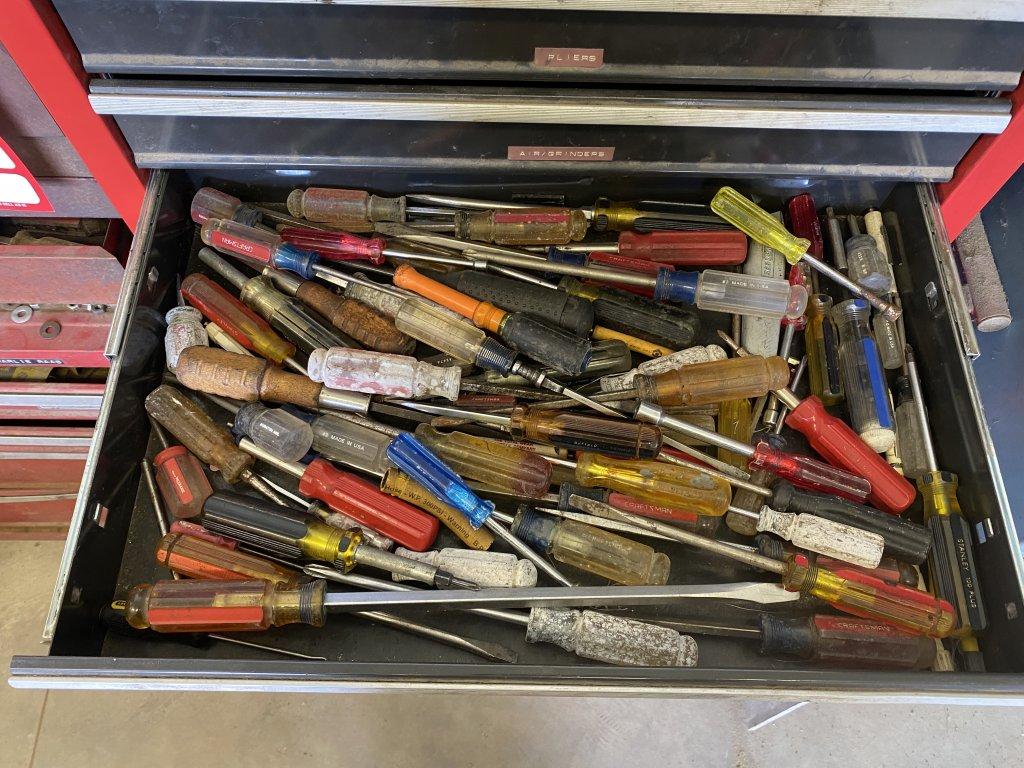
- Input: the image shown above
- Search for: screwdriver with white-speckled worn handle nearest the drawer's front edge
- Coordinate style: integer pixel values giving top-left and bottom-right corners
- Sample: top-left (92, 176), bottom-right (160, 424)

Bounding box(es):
top-left (305, 565), bottom-right (697, 667)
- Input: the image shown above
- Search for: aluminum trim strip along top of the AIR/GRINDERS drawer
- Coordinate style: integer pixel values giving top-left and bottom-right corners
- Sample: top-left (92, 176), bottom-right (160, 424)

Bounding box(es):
top-left (89, 92), bottom-right (1010, 133)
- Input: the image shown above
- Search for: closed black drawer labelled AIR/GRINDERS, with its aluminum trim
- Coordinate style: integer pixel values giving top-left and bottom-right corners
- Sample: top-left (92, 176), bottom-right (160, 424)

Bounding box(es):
top-left (91, 80), bottom-right (1010, 183)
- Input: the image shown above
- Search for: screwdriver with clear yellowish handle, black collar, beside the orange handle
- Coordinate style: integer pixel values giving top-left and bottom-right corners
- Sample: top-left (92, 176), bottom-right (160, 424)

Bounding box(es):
top-left (394, 299), bottom-right (620, 417)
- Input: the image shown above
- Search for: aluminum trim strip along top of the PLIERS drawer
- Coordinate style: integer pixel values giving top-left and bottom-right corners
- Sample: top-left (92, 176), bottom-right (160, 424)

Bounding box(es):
top-left (128, 0), bottom-right (1024, 22)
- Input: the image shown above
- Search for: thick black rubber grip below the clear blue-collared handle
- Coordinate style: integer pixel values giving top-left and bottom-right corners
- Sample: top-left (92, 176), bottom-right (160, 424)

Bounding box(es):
top-left (594, 288), bottom-right (700, 350)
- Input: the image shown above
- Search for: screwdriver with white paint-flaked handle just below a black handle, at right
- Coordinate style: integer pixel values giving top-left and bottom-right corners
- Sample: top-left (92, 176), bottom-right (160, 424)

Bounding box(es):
top-left (570, 497), bottom-right (885, 568)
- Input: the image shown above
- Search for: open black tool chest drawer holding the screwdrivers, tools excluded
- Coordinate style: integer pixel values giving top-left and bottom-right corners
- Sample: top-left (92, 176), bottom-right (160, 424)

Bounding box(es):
top-left (11, 165), bottom-right (1024, 701)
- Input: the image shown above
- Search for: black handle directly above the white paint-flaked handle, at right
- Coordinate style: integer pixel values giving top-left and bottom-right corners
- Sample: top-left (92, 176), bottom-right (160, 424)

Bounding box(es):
top-left (771, 480), bottom-right (932, 565)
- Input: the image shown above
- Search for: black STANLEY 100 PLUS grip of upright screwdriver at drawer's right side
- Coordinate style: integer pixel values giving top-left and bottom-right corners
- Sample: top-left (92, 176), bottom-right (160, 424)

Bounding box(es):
top-left (927, 514), bottom-right (988, 633)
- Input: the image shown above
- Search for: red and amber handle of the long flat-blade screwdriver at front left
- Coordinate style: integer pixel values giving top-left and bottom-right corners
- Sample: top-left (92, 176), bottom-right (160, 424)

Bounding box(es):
top-left (125, 579), bottom-right (326, 632)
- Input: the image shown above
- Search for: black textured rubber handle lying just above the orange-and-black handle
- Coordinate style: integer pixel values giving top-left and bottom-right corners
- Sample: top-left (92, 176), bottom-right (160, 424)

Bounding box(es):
top-left (437, 269), bottom-right (594, 336)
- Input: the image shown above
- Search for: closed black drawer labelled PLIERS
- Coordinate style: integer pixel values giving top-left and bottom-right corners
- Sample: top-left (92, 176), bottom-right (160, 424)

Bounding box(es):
top-left (54, 0), bottom-right (1024, 90)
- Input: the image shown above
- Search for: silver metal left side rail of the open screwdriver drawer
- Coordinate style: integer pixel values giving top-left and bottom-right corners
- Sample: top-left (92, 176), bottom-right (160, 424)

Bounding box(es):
top-left (43, 172), bottom-right (167, 642)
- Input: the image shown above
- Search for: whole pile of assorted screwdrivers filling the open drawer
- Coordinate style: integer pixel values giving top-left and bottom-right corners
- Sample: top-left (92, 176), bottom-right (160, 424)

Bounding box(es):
top-left (115, 187), bottom-right (985, 670)
